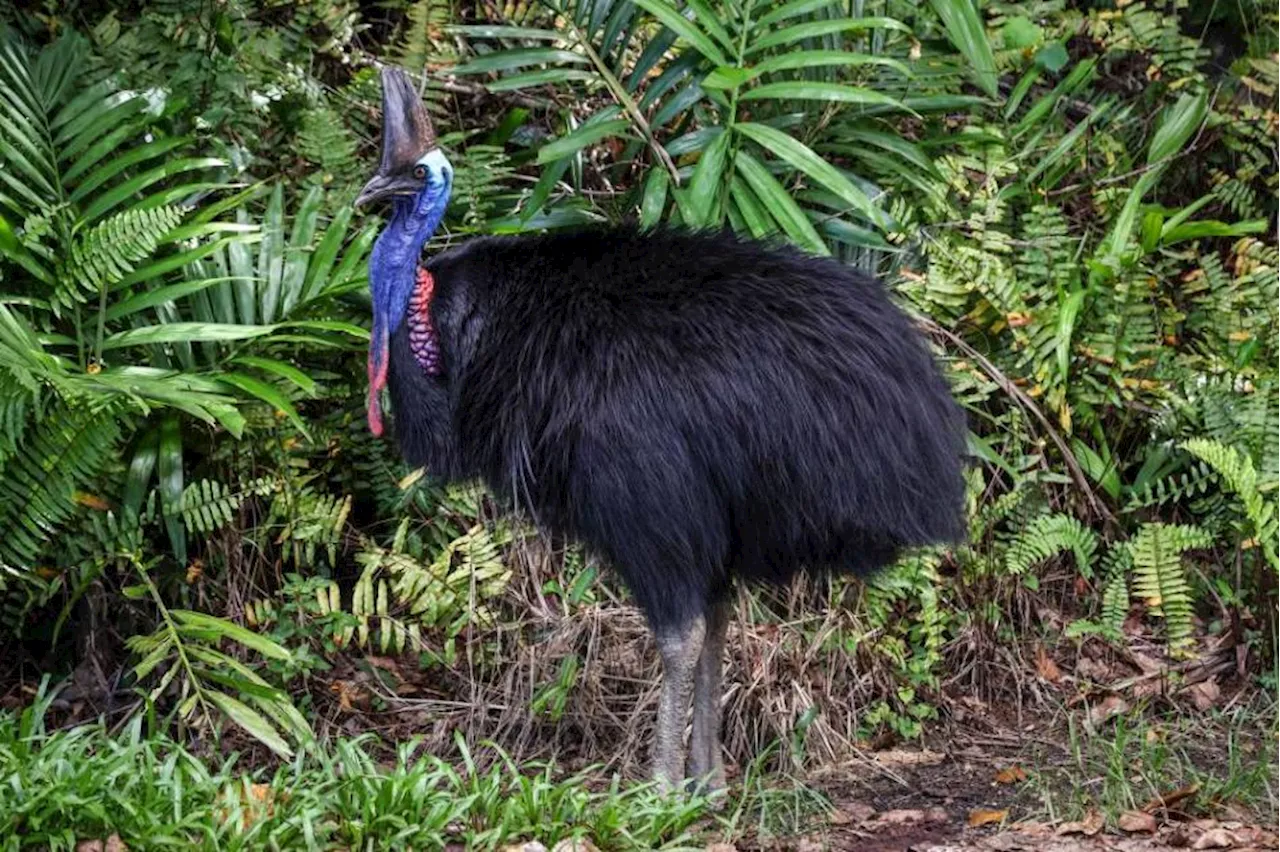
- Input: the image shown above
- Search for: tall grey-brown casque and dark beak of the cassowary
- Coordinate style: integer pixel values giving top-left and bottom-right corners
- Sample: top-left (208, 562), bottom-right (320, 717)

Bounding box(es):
top-left (356, 68), bottom-right (435, 207)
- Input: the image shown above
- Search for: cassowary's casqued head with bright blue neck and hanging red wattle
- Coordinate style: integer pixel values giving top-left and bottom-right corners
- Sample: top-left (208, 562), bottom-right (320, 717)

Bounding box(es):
top-left (356, 68), bottom-right (453, 435)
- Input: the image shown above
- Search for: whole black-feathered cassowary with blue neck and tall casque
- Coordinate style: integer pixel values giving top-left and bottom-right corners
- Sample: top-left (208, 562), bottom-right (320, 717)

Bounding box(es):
top-left (357, 69), bottom-right (965, 788)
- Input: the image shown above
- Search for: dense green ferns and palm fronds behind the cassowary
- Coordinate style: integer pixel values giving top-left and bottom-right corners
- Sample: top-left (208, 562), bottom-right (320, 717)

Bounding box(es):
top-left (0, 0), bottom-right (1280, 777)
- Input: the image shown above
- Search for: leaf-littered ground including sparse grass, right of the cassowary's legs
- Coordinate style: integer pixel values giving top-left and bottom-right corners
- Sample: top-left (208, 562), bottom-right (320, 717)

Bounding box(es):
top-left (709, 709), bottom-right (1280, 852)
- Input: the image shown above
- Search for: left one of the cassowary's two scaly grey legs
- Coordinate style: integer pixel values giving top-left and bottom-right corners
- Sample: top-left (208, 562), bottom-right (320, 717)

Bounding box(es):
top-left (653, 615), bottom-right (707, 792)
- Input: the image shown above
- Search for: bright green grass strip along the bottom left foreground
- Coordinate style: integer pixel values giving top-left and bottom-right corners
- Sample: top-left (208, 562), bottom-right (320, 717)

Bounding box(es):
top-left (0, 680), bottom-right (709, 852)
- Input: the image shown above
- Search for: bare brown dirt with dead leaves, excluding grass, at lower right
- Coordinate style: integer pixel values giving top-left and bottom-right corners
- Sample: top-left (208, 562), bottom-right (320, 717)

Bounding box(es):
top-left (708, 721), bottom-right (1280, 852)
